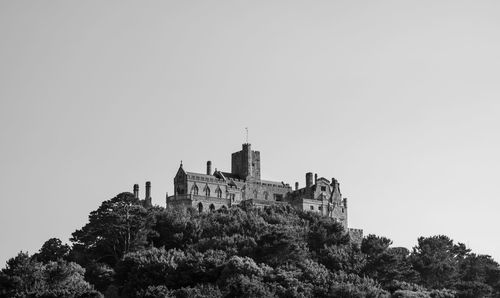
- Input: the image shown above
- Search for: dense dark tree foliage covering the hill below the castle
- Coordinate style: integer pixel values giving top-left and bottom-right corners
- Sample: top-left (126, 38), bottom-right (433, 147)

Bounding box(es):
top-left (0, 193), bottom-right (500, 298)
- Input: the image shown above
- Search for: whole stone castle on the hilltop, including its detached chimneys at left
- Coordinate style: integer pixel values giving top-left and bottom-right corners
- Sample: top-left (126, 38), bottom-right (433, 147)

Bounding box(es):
top-left (164, 143), bottom-right (363, 243)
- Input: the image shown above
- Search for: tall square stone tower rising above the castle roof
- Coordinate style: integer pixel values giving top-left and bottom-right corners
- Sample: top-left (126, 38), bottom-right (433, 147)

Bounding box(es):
top-left (231, 143), bottom-right (260, 180)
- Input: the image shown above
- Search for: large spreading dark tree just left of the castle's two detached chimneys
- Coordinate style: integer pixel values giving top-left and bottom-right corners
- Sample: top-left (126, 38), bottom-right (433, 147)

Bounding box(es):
top-left (71, 192), bottom-right (154, 266)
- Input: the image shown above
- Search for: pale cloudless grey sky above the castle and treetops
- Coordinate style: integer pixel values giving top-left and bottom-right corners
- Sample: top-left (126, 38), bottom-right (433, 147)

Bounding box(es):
top-left (0, 0), bottom-right (500, 267)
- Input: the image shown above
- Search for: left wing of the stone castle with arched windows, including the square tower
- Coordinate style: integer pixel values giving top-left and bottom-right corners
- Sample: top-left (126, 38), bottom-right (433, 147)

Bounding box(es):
top-left (167, 144), bottom-right (292, 212)
